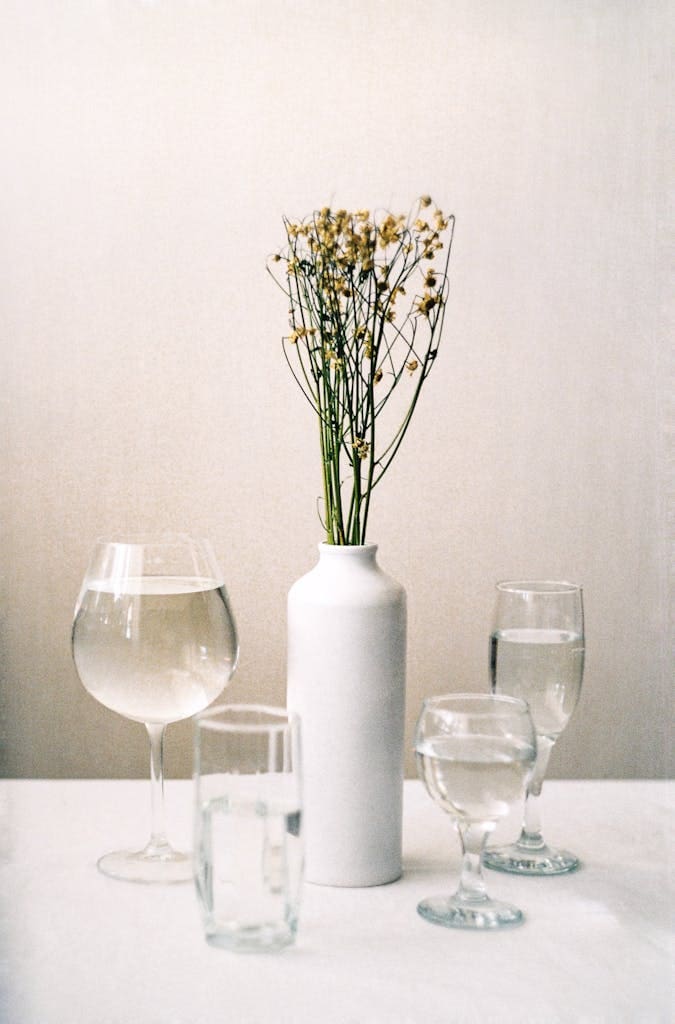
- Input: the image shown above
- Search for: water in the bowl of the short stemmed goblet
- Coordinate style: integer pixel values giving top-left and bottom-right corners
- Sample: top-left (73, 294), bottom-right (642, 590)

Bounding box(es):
top-left (416, 735), bottom-right (535, 822)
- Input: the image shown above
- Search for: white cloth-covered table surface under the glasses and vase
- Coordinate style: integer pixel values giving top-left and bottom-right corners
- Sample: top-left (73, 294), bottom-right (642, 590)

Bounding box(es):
top-left (0, 780), bottom-right (675, 1024)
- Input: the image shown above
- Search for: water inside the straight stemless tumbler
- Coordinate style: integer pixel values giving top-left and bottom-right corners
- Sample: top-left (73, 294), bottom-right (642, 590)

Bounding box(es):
top-left (195, 797), bottom-right (302, 951)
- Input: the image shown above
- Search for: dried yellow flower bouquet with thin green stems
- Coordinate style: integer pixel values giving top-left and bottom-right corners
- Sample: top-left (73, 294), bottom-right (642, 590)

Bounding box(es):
top-left (270, 196), bottom-right (455, 545)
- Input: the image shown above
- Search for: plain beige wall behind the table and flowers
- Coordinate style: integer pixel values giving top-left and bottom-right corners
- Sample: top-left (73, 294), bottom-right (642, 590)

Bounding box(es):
top-left (0, 0), bottom-right (675, 777)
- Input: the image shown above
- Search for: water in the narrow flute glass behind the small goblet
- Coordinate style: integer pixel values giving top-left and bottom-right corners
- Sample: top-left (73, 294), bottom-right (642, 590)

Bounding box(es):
top-left (490, 629), bottom-right (584, 738)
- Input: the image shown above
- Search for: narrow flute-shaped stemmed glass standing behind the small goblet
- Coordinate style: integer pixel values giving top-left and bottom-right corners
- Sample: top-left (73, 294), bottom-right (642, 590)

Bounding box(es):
top-left (484, 580), bottom-right (584, 874)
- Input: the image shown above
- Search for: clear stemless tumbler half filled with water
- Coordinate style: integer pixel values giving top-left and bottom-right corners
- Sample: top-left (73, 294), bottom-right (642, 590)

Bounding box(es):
top-left (194, 705), bottom-right (303, 952)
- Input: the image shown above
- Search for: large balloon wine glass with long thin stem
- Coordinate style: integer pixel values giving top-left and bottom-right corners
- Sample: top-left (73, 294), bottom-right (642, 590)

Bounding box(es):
top-left (72, 534), bottom-right (239, 882)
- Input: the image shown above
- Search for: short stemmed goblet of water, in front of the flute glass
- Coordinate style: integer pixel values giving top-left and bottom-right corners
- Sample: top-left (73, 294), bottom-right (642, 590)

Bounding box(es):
top-left (415, 693), bottom-right (537, 929)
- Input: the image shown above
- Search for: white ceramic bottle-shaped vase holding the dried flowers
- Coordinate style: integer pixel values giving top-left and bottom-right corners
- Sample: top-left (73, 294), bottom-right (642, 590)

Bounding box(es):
top-left (288, 544), bottom-right (406, 886)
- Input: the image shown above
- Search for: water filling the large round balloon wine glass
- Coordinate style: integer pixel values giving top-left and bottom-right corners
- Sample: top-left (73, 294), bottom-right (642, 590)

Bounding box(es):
top-left (73, 577), bottom-right (237, 723)
